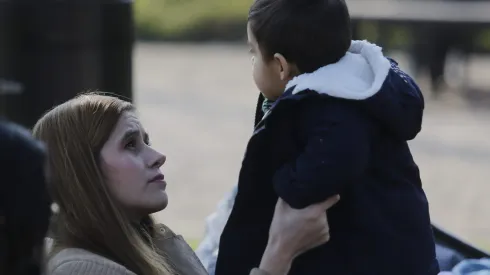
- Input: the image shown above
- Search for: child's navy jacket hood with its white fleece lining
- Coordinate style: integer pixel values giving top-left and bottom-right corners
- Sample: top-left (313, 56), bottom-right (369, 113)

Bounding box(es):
top-left (286, 41), bottom-right (424, 140)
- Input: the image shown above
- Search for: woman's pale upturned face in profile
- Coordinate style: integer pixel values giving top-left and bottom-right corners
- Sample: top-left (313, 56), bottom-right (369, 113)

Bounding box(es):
top-left (100, 112), bottom-right (168, 219)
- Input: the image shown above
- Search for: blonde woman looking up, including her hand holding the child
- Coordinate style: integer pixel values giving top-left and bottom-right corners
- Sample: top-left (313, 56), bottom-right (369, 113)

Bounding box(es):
top-left (33, 94), bottom-right (338, 275)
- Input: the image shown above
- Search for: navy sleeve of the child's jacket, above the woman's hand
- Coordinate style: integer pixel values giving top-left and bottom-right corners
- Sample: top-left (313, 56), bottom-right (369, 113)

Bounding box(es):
top-left (273, 100), bottom-right (370, 208)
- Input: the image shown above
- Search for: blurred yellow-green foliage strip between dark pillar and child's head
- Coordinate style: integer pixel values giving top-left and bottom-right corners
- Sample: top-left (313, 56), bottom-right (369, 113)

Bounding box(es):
top-left (134, 0), bottom-right (252, 39)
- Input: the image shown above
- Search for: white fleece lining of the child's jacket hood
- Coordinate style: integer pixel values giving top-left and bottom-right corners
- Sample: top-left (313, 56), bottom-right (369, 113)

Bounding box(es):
top-left (286, 41), bottom-right (391, 100)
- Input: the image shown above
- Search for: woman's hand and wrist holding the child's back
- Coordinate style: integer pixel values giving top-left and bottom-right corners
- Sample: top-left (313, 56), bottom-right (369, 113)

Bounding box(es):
top-left (260, 195), bottom-right (340, 275)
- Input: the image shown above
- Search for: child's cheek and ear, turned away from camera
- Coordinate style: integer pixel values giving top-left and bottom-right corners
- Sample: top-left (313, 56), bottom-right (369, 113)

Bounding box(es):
top-left (247, 23), bottom-right (293, 100)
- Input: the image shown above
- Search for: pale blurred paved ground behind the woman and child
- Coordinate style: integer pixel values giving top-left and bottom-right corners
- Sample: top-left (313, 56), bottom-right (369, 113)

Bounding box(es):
top-left (135, 44), bottom-right (490, 250)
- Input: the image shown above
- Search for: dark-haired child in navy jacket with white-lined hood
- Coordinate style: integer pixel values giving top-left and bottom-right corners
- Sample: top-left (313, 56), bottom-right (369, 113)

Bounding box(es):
top-left (216, 0), bottom-right (439, 275)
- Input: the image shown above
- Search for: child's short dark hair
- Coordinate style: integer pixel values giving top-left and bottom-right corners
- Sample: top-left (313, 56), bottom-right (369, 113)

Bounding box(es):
top-left (248, 0), bottom-right (352, 73)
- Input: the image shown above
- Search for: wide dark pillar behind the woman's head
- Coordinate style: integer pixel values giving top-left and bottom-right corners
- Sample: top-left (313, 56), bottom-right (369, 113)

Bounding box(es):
top-left (0, 0), bottom-right (133, 127)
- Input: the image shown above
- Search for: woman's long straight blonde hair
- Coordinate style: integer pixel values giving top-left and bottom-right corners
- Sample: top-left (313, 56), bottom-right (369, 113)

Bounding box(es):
top-left (33, 93), bottom-right (172, 275)
